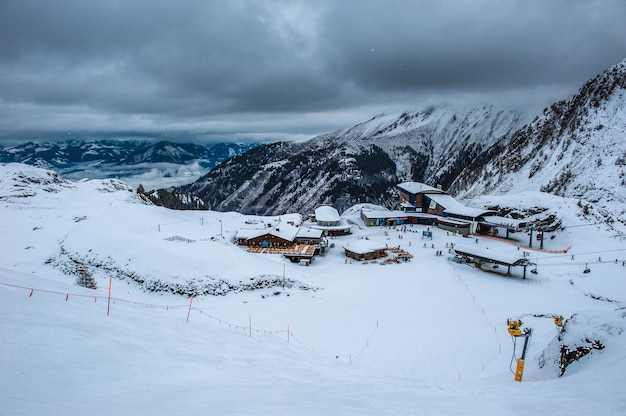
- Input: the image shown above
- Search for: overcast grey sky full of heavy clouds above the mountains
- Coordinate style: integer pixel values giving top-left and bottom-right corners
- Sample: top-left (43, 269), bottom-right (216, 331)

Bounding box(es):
top-left (0, 0), bottom-right (626, 142)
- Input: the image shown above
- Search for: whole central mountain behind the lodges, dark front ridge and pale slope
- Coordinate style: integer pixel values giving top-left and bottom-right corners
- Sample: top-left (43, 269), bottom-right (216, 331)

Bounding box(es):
top-left (174, 107), bottom-right (525, 214)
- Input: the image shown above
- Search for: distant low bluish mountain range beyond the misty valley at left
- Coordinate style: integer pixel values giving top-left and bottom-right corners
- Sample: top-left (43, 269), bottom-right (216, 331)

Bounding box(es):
top-left (0, 140), bottom-right (258, 189)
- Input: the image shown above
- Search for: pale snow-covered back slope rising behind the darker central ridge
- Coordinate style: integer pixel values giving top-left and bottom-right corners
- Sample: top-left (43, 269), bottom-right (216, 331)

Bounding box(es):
top-left (330, 106), bottom-right (525, 188)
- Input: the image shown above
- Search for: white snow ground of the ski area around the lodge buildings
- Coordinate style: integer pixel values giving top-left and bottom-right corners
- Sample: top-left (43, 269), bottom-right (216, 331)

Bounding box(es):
top-left (0, 164), bottom-right (626, 415)
